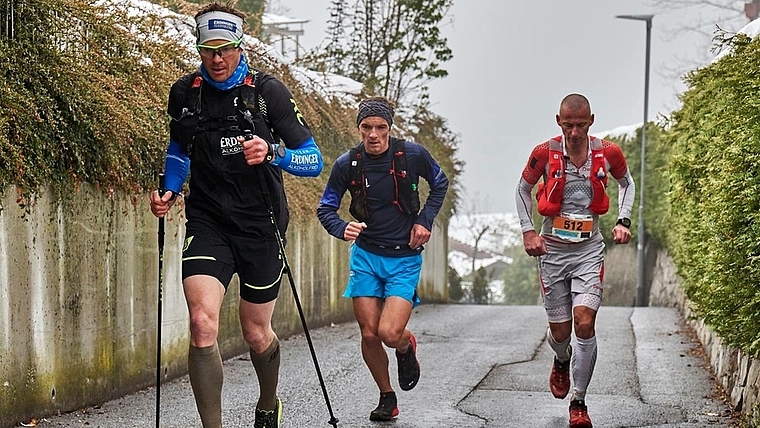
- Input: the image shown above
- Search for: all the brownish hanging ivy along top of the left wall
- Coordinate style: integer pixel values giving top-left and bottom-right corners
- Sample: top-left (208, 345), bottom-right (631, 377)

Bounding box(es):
top-left (0, 0), bottom-right (461, 219)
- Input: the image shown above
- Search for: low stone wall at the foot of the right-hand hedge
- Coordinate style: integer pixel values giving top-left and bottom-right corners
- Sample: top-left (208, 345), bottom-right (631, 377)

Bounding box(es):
top-left (649, 252), bottom-right (760, 426)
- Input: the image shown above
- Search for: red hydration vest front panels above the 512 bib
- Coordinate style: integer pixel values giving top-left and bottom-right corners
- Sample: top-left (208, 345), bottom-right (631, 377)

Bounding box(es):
top-left (536, 136), bottom-right (610, 217)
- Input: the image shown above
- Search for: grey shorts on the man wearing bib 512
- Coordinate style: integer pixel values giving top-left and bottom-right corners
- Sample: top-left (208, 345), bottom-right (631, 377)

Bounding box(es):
top-left (538, 233), bottom-right (604, 322)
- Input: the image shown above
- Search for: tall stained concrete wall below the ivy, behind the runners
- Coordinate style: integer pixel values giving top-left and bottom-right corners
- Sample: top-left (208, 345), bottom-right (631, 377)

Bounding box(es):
top-left (0, 186), bottom-right (448, 426)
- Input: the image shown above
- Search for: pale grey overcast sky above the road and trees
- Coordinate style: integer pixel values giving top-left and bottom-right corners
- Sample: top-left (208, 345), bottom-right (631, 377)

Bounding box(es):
top-left (272, 0), bottom-right (744, 213)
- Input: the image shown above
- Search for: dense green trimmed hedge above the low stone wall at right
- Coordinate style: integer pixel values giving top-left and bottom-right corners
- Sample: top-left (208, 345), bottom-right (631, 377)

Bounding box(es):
top-left (667, 35), bottom-right (760, 356)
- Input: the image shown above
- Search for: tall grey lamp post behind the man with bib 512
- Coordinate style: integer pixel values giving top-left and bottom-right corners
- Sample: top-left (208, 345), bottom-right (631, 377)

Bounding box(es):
top-left (615, 15), bottom-right (654, 306)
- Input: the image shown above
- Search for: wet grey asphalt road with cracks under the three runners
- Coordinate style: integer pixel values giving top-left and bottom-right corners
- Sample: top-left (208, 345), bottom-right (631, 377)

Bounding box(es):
top-left (31, 305), bottom-right (735, 428)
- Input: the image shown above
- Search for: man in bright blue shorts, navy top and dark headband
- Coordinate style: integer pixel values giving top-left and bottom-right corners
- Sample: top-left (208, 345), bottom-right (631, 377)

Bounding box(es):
top-left (317, 97), bottom-right (449, 421)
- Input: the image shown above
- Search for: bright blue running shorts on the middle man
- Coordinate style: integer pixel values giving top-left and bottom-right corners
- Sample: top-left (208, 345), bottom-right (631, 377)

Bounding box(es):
top-left (343, 245), bottom-right (422, 307)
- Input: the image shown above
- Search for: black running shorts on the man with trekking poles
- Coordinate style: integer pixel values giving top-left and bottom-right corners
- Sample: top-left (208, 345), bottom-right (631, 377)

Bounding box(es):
top-left (182, 221), bottom-right (285, 303)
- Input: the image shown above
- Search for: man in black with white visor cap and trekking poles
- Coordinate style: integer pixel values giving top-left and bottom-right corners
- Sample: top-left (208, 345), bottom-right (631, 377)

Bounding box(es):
top-left (150, 3), bottom-right (335, 428)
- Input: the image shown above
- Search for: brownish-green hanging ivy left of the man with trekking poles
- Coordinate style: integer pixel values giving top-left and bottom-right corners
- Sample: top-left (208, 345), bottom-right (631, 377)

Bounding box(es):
top-left (0, 0), bottom-right (190, 202)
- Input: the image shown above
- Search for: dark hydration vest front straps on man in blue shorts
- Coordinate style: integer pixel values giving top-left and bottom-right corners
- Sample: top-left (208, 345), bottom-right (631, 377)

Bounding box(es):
top-left (348, 137), bottom-right (420, 221)
